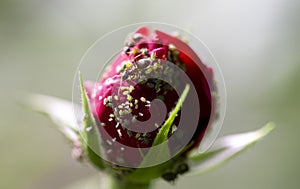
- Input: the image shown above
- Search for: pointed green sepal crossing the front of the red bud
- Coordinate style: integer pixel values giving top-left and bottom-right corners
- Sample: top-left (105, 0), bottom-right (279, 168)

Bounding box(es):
top-left (141, 84), bottom-right (190, 167)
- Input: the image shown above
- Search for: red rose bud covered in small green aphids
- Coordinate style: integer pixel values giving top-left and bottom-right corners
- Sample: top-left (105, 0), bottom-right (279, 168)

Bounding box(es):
top-left (85, 27), bottom-right (214, 169)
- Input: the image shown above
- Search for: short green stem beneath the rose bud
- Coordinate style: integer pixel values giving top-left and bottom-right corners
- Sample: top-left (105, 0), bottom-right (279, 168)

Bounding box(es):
top-left (110, 176), bottom-right (151, 189)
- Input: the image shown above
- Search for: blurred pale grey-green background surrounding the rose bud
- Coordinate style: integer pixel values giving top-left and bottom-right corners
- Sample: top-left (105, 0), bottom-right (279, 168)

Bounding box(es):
top-left (0, 0), bottom-right (300, 189)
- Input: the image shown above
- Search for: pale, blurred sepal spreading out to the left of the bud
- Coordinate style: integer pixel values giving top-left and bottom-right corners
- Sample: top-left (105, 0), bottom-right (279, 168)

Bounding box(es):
top-left (25, 94), bottom-right (80, 142)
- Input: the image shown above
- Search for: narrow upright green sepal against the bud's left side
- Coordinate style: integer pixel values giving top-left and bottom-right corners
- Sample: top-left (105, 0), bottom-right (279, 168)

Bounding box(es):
top-left (79, 73), bottom-right (104, 169)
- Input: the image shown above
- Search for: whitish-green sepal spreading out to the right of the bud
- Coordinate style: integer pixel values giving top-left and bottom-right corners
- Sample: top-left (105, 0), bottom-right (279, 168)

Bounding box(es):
top-left (188, 123), bottom-right (275, 175)
